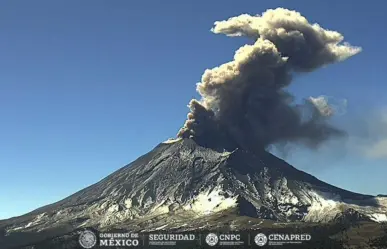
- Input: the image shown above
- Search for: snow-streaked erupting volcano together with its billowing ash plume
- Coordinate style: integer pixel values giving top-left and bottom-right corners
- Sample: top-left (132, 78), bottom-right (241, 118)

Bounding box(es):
top-left (0, 8), bottom-right (387, 248)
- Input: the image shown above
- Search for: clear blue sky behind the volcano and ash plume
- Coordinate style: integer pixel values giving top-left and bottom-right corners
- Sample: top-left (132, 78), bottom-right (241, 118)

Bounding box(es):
top-left (0, 0), bottom-right (387, 219)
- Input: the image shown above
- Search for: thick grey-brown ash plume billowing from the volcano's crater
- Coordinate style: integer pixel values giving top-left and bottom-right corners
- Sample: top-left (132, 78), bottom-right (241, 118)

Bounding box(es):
top-left (178, 8), bottom-right (361, 150)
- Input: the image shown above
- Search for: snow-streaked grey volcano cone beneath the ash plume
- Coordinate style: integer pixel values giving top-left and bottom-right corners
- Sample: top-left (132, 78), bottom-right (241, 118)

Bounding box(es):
top-left (0, 139), bottom-right (387, 248)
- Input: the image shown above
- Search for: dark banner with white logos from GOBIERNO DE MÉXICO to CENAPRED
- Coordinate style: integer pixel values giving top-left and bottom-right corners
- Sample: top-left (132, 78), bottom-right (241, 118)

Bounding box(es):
top-left (79, 230), bottom-right (324, 249)
